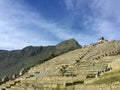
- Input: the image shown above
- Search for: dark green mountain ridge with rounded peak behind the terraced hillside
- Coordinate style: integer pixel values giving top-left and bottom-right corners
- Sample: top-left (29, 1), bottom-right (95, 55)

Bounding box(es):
top-left (0, 39), bottom-right (81, 78)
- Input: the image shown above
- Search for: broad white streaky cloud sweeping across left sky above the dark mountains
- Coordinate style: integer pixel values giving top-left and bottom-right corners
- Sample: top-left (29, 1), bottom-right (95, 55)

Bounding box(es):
top-left (0, 0), bottom-right (95, 49)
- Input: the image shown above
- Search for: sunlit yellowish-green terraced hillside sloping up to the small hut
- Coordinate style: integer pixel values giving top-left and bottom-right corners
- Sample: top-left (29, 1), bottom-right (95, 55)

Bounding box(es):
top-left (0, 41), bottom-right (120, 90)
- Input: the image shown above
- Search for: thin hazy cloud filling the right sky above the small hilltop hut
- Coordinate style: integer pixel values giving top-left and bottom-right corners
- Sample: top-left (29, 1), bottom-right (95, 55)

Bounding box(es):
top-left (65, 0), bottom-right (120, 39)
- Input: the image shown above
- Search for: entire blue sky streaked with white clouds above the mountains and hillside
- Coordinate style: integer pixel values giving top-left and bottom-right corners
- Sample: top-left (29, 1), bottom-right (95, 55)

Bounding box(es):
top-left (0, 0), bottom-right (120, 50)
